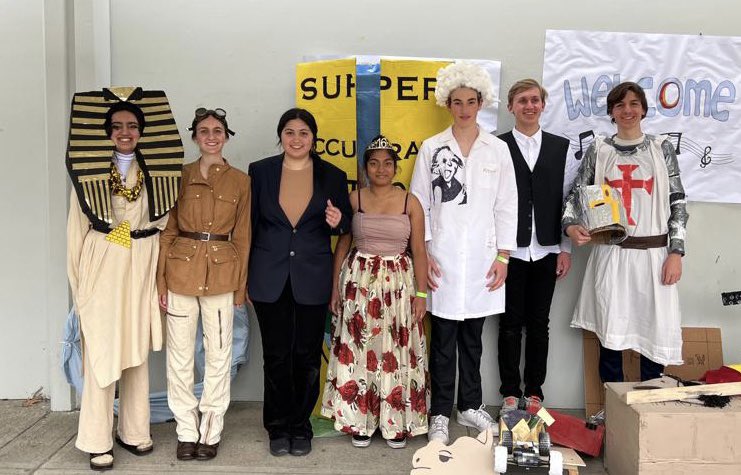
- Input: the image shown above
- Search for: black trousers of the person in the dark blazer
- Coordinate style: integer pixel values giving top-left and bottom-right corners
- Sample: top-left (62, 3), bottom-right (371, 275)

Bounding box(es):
top-left (253, 277), bottom-right (327, 439)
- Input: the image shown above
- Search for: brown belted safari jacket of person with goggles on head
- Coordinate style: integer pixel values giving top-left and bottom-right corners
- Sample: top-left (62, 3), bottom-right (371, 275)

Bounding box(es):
top-left (157, 159), bottom-right (252, 305)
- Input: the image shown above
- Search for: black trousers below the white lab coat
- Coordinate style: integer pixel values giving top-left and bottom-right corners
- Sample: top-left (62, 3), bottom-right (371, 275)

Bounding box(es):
top-left (430, 315), bottom-right (485, 417)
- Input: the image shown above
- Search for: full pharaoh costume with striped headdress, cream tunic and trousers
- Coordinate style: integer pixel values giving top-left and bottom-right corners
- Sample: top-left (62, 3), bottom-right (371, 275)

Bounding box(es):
top-left (66, 88), bottom-right (183, 458)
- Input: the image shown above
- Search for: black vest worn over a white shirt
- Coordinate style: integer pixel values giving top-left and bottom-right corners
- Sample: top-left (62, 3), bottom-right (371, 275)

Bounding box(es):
top-left (499, 132), bottom-right (569, 247)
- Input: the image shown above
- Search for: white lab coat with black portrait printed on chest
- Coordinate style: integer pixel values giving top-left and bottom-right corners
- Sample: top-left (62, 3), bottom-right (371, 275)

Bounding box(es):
top-left (411, 127), bottom-right (517, 320)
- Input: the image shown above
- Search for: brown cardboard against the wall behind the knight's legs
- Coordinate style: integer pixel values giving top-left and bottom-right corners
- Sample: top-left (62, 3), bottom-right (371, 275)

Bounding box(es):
top-left (583, 327), bottom-right (723, 417)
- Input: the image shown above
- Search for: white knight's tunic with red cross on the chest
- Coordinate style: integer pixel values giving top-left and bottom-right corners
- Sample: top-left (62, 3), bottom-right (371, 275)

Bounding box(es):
top-left (571, 137), bottom-right (682, 365)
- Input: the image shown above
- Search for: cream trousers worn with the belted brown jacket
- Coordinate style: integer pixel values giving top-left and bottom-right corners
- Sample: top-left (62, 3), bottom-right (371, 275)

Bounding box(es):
top-left (167, 291), bottom-right (234, 445)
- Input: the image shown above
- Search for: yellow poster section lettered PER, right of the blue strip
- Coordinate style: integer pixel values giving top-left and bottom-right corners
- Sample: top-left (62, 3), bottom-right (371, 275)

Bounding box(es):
top-left (381, 59), bottom-right (451, 188)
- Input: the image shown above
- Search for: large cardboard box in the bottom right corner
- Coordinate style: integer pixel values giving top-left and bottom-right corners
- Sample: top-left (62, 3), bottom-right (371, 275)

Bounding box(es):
top-left (605, 383), bottom-right (741, 475)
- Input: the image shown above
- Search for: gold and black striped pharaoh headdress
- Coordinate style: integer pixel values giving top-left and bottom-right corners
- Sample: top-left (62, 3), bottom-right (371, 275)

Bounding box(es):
top-left (66, 87), bottom-right (184, 231)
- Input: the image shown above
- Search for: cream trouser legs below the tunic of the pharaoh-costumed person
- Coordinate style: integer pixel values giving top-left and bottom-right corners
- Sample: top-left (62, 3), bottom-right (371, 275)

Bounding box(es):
top-left (75, 338), bottom-right (152, 454)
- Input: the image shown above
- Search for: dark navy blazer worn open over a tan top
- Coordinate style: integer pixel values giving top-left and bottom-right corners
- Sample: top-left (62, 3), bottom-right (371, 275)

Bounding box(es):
top-left (248, 154), bottom-right (352, 305)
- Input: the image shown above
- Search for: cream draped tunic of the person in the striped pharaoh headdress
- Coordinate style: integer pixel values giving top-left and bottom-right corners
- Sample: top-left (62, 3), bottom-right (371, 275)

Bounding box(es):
top-left (67, 162), bottom-right (169, 388)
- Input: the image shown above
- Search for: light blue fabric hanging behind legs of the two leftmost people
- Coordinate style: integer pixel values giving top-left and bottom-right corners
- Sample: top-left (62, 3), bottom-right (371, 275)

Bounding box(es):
top-left (62, 305), bottom-right (249, 423)
